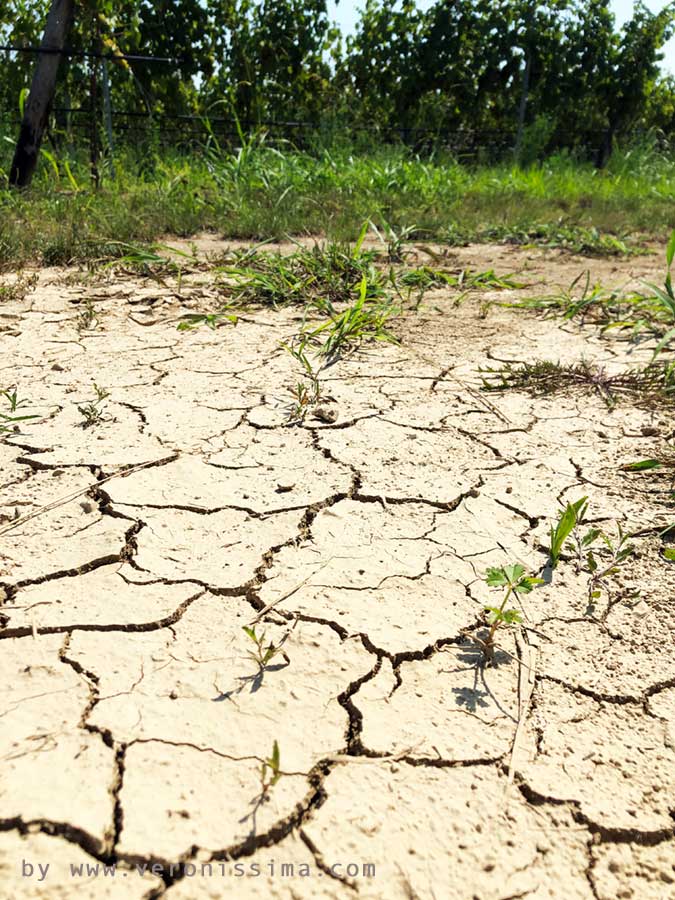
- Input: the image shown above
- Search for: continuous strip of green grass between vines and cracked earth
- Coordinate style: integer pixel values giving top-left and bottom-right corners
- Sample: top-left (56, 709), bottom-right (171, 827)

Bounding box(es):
top-left (0, 140), bottom-right (675, 269)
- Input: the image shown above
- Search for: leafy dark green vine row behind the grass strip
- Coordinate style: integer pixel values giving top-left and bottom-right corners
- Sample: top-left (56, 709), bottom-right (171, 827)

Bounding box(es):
top-left (0, 0), bottom-right (675, 164)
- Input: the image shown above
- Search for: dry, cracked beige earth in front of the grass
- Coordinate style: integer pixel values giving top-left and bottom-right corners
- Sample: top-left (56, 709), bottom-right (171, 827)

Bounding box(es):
top-left (0, 242), bottom-right (675, 900)
